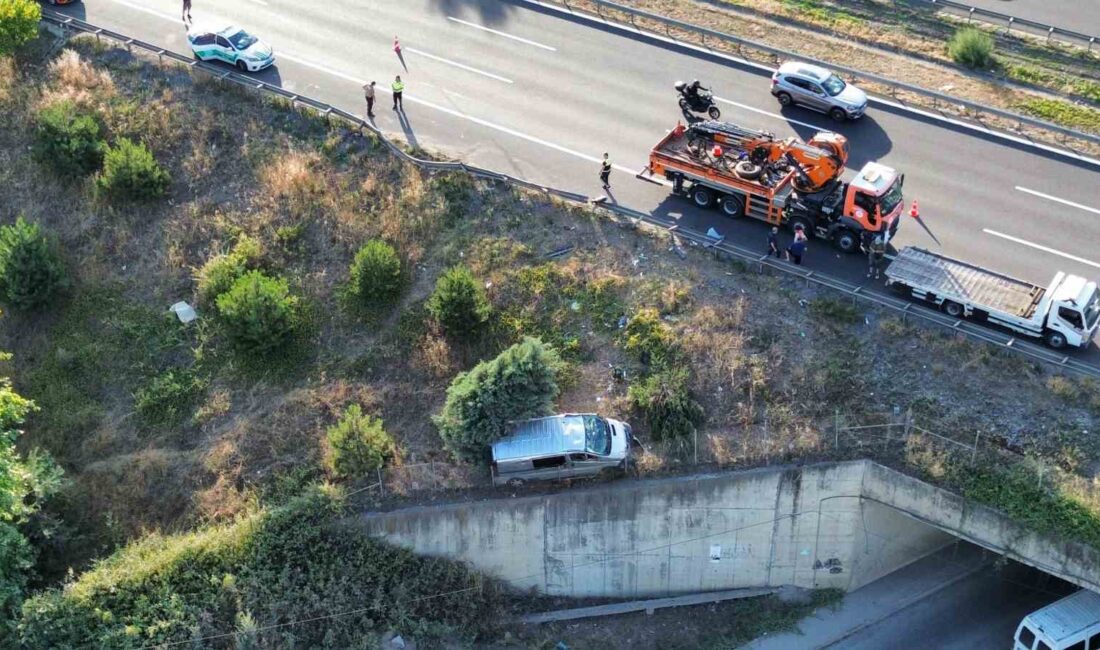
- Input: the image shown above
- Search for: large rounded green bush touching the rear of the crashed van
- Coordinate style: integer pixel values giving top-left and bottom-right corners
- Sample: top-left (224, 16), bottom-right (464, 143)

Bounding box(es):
top-left (435, 338), bottom-right (561, 461)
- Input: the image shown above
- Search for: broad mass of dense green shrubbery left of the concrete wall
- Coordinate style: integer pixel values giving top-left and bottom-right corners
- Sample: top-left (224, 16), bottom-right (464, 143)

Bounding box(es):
top-left (13, 488), bottom-right (505, 650)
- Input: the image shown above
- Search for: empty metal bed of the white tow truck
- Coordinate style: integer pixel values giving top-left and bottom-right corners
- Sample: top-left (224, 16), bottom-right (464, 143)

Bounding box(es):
top-left (886, 246), bottom-right (1045, 319)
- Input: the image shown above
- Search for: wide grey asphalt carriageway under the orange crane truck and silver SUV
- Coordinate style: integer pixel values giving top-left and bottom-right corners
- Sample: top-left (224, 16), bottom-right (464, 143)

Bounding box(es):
top-left (49, 0), bottom-right (1100, 360)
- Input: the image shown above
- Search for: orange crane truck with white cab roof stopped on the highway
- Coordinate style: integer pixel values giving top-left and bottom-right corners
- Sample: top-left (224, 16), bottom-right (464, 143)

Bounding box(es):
top-left (639, 120), bottom-right (905, 253)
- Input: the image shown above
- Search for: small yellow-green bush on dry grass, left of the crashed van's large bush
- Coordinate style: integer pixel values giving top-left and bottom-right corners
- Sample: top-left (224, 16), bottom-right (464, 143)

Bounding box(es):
top-left (325, 404), bottom-right (395, 477)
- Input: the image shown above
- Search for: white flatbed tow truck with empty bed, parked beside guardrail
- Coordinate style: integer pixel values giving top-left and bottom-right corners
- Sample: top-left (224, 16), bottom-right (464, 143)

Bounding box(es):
top-left (886, 246), bottom-right (1100, 348)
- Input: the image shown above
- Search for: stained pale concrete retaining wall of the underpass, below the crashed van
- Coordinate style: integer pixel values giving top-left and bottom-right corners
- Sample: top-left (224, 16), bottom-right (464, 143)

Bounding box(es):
top-left (363, 461), bottom-right (1100, 597)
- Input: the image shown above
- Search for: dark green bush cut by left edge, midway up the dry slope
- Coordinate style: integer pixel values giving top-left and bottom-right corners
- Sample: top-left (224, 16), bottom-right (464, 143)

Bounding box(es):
top-left (0, 217), bottom-right (65, 309)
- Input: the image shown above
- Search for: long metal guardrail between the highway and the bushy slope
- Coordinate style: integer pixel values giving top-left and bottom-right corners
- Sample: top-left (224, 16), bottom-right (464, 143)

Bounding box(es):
top-left (43, 10), bottom-right (1100, 378)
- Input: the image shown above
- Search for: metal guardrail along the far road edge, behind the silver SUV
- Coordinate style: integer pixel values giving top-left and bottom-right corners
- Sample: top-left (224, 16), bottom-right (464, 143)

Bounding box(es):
top-left (539, 0), bottom-right (1100, 145)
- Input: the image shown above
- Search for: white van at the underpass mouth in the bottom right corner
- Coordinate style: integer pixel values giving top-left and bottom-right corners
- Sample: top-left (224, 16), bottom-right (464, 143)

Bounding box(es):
top-left (1013, 590), bottom-right (1100, 650)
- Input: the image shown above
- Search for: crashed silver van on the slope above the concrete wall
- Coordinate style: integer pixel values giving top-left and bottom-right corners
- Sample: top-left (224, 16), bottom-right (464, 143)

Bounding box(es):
top-left (492, 414), bottom-right (637, 487)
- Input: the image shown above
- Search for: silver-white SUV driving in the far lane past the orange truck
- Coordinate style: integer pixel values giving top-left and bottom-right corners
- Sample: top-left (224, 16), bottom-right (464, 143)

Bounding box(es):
top-left (771, 62), bottom-right (867, 122)
